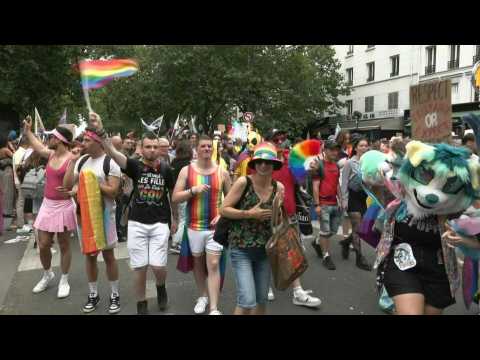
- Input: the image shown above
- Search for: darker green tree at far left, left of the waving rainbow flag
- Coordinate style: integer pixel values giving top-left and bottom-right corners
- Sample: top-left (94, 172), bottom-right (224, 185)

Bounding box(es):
top-left (0, 45), bottom-right (81, 126)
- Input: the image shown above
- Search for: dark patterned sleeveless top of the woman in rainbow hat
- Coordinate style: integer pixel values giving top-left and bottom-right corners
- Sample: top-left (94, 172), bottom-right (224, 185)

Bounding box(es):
top-left (228, 179), bottom-right (277, 249)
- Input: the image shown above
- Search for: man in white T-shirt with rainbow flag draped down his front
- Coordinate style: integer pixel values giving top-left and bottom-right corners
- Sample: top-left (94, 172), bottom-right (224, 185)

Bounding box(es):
top-left (63, 113), bottom-right (121, 314)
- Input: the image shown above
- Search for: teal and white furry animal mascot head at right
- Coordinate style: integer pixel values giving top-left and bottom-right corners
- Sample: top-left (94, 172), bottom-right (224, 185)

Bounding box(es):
top-left (360, 141), bottom-right (480, 218)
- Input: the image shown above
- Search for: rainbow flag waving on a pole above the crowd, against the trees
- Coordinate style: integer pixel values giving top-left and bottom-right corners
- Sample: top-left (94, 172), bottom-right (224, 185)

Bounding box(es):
top-left (79, 59), bottom-right (138, 90)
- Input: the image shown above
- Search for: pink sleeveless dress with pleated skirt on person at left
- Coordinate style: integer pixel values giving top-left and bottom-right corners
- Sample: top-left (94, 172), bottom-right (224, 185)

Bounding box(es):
top-left (33, 156), bottom-right (77, 233)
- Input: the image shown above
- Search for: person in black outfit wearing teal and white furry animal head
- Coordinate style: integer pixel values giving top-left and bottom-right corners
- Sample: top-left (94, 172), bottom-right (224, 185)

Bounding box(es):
top-left (360, 136), bottom-right (480, 315)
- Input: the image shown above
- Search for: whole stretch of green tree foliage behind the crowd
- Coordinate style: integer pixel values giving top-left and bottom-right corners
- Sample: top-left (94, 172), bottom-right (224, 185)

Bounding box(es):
top-left (0, 45), bottom-right (349, 136)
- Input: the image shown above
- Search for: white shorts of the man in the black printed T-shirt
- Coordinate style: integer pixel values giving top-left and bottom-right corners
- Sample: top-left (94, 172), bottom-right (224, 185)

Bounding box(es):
top-left (127, 221), bottom-right (170, 269)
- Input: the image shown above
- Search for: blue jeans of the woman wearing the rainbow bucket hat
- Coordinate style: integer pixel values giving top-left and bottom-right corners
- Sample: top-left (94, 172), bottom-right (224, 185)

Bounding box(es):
top-left (230, 247), bottom-right (271, 309)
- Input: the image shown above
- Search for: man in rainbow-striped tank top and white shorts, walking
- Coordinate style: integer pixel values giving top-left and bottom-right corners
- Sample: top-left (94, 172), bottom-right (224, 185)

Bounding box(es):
top-left (172, 135), bottom-right (231, 315)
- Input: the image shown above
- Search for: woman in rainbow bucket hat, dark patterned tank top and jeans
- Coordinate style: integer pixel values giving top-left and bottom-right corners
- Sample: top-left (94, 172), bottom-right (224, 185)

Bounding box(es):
top-left (220, 143), bottom-right (285, 315)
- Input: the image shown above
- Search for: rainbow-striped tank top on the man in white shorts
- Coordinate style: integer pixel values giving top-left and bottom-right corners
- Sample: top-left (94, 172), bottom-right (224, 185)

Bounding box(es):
top-left (187, 165), bottom-right (222, 231)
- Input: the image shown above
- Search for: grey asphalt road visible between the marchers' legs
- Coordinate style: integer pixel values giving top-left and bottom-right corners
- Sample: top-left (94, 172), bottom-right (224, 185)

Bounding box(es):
top-left (0, 228), bottom-right (478, 316)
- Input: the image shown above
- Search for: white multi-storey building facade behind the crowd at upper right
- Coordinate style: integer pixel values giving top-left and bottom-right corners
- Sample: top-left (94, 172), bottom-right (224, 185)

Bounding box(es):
top-left (329, 45), bottom-right (480, 138)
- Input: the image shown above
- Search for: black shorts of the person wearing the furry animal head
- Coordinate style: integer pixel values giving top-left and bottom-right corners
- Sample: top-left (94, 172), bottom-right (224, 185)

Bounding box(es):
top-left (384, 245), bottom-right (455, 309)
